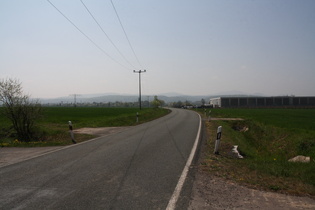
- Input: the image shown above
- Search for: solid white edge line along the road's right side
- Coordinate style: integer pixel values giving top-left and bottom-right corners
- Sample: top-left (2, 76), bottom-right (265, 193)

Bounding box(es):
top-left (166, 113), bottom-right (201, 210)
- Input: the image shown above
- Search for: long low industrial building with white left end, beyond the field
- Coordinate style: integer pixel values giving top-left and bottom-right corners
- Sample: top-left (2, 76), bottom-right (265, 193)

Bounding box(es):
top-left (210, 96), bottom-right (315, 108)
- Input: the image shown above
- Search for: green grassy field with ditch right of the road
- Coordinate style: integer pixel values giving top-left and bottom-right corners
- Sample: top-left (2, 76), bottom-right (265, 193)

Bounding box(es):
top-left (202, 109), bottom-right (315, 196)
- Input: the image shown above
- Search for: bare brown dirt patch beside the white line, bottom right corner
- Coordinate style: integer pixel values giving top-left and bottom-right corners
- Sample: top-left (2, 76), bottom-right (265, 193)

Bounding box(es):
top-left (188, 169), bottom-right (315, 210)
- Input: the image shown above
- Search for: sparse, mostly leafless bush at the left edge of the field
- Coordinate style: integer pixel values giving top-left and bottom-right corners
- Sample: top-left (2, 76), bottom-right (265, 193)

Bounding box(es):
top-left (0, 79), bottom-right (42, 142)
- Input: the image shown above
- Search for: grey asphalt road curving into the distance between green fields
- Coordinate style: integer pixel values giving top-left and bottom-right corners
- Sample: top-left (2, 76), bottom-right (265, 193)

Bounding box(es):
top-left (0, 109), bottom-right (199, 209)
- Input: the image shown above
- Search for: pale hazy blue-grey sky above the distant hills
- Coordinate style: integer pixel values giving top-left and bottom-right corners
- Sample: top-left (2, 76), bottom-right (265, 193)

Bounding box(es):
top-left (0, 0), bottom-right (315, 98)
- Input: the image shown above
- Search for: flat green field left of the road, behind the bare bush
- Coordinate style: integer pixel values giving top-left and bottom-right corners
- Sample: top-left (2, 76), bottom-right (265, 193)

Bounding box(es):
top-left (0, 107), bottom-right (169, 146)
